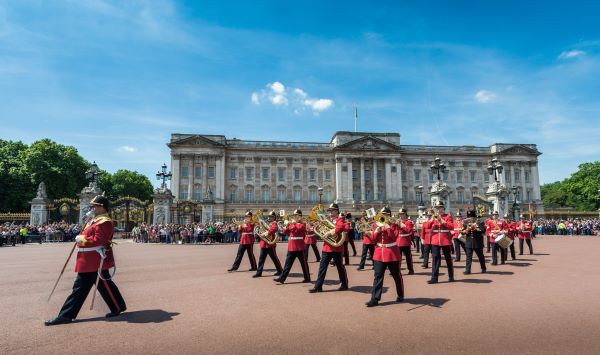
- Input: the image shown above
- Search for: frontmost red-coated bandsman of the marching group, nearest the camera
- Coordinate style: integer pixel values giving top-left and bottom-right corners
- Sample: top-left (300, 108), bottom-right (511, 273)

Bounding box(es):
top-left (365, 207), bottom-right (404, 307)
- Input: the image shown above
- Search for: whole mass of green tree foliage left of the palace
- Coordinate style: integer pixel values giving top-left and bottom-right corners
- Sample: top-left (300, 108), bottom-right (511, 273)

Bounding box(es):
top-left (0, 139), bottom-right (152, 212)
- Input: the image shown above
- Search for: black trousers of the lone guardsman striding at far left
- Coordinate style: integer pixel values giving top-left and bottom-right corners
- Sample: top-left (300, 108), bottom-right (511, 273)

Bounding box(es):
top-left (58, 270), bottom-right (126, 319)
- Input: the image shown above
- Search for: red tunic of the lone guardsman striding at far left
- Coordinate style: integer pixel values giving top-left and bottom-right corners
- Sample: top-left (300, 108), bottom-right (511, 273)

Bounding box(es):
top-left (75, 214), bottom-right (115, 272)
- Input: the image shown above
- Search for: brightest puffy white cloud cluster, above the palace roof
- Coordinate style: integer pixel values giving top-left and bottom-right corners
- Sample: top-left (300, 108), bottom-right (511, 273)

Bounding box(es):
top-left (250, 81), bottom-right (334, 115)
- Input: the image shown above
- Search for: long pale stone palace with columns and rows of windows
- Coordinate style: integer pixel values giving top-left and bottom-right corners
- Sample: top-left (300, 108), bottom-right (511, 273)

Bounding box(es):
top-left (167, 131), bottom-right (543, 222)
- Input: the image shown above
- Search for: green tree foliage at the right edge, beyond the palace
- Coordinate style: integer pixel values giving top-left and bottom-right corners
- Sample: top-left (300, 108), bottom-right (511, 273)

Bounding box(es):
top-left (541, 161), bottom-right (600, 211)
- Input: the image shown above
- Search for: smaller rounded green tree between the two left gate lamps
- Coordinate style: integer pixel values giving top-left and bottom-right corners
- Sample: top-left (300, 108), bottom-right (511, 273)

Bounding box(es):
top-left (106, 169), bottom-right (152, 201)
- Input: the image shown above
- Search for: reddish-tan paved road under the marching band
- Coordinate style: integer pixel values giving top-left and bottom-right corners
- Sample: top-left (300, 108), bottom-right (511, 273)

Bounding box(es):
top-left (0, 236), bottom-right (600, 354)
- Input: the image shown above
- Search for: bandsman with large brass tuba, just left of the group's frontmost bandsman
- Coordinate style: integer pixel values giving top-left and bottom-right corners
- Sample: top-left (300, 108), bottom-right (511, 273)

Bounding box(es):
top-left (308, 203), bottom-right (348, 293)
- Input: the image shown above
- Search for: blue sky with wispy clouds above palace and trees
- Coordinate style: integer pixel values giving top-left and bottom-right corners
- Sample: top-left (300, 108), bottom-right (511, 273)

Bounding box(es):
top-left (0, 0), bottom-right (600, 185)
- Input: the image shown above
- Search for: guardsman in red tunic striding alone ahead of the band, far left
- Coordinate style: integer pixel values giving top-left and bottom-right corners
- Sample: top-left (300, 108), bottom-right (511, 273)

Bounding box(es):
top-left (44, 196), bottom-right (127, 325)
